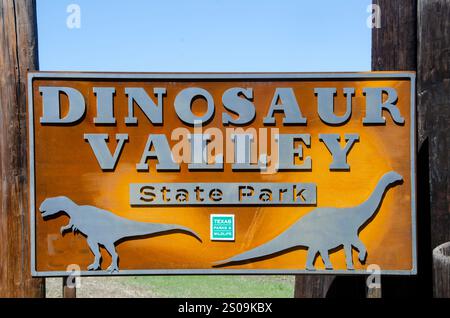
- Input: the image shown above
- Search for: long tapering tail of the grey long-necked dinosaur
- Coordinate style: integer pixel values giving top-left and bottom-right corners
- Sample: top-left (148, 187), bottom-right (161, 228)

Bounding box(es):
top-left (213, 222), bottom-right (302, 266)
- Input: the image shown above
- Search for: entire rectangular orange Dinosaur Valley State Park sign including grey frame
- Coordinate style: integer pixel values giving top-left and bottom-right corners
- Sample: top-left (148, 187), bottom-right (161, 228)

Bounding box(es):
top-left (28, 72), bottom-right (416, 276)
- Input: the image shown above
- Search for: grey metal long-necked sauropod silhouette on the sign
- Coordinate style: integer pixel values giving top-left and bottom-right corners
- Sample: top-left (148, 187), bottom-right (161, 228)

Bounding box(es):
top-left (214, 171), bottom-right (403, 270)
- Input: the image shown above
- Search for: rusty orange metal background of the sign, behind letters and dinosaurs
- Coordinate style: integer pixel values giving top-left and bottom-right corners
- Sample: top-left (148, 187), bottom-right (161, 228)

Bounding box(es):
top-left (27, 73), bottom-right (414, 275)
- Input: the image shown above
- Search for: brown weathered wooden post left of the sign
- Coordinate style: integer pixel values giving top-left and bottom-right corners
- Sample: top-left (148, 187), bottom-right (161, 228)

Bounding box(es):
top-left (0, 0), bottom-right (45, 297)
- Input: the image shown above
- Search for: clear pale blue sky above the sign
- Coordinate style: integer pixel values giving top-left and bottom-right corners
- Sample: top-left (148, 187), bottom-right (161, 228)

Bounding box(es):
top-left (37, 0), bottom-right (371, 72)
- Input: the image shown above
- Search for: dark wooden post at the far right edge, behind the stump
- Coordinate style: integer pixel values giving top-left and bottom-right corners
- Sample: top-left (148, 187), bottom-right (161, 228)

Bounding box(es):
top-left (417, 0), bottom-right (450, 297)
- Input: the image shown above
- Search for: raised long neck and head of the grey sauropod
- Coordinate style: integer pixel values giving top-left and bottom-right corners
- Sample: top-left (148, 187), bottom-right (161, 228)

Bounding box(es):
top-left (352, 176), bottom-right (392, 228)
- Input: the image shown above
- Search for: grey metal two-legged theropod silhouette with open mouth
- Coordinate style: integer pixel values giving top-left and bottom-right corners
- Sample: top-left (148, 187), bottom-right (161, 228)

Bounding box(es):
top-left (39, 196), bottom-right (201, 273)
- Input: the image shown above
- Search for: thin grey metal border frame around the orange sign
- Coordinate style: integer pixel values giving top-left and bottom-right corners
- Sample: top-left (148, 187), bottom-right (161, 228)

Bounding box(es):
top-left (27, 71), bottom-right (417, 277)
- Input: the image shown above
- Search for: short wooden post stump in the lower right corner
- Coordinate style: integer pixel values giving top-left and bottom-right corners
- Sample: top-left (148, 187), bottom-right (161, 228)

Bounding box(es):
top-left (433, 242), bottom-right (450, 298)
